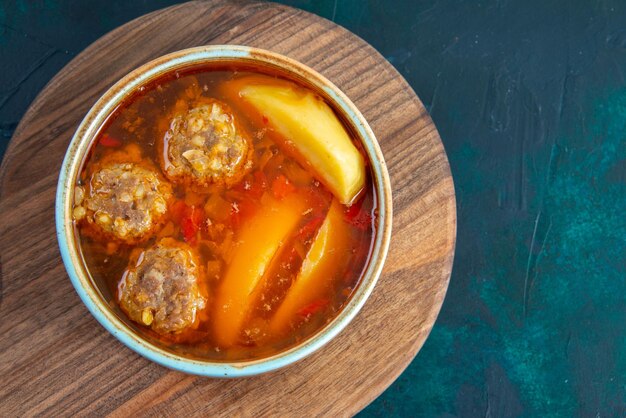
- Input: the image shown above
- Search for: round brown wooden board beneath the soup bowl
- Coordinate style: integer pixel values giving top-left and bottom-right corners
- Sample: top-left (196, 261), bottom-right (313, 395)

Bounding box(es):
top-left (0, 1), bottom-right (456, 416)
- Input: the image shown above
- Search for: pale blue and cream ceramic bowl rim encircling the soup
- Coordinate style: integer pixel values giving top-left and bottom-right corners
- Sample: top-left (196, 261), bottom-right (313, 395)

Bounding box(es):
top-left (55, 45), bottom-right (392, 377)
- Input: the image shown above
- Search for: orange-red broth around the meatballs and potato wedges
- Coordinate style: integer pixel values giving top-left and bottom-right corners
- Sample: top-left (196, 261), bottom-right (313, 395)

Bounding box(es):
top-left (75, 67), bottom-right (376, 361)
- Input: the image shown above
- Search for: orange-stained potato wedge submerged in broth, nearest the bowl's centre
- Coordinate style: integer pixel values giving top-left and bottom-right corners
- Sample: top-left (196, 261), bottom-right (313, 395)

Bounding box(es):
top-left (213, 193), bottom-right (306, 347)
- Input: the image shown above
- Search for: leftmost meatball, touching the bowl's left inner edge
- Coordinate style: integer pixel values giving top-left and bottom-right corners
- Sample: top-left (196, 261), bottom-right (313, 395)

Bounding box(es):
top-left (73, 163), bottom-right (172, 243)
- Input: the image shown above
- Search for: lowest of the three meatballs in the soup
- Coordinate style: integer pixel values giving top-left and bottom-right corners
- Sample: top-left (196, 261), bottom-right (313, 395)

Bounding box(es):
top-left (118, 238), bottom-right (206, 335)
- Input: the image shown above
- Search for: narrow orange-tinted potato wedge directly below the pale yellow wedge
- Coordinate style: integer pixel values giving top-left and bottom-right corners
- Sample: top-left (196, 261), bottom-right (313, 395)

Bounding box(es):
top-left (270, 200), bottom-right (349, 335)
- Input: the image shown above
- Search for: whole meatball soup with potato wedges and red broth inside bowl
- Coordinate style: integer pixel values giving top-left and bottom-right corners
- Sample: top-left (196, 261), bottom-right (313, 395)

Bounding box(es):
top-left (73, 66), bottom-right (377, 361)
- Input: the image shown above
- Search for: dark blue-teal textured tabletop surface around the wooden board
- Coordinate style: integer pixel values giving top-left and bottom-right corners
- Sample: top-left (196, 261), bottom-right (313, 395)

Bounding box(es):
top-left (0, 0), bottom-right (626, 417)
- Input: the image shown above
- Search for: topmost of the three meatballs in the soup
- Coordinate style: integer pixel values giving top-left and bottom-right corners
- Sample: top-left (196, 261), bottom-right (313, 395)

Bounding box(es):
top-left (163, 100), bottom-right (252, 186)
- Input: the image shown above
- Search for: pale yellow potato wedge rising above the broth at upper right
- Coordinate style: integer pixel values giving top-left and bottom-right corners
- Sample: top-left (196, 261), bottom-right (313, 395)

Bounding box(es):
top-left (239, 83), bottom-right (365, 205)
